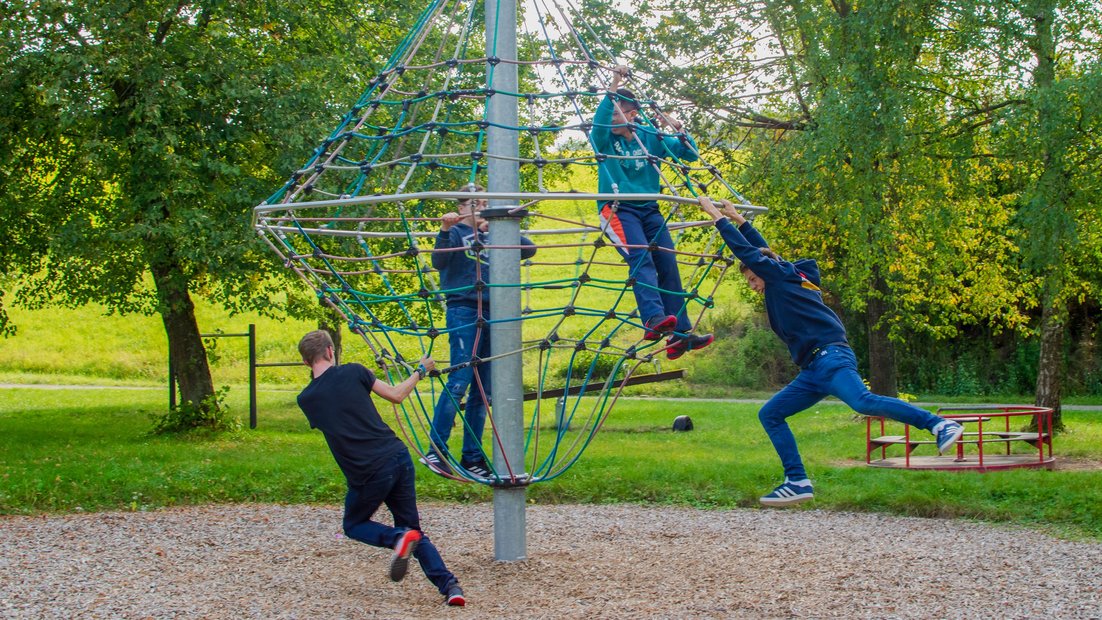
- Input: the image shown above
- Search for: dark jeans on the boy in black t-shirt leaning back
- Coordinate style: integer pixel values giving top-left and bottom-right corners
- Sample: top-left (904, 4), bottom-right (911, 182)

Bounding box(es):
top-left (344, 449), bottom-right (455, 594)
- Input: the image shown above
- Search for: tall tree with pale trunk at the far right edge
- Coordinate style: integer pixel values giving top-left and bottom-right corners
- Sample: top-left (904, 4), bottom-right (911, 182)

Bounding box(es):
top-left (1001, 0), bottom-right (1102, 427)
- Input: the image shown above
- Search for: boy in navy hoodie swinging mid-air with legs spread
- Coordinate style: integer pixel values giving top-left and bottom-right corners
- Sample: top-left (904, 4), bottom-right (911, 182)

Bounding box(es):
top-left (700, 196), bottom-right (963, 505)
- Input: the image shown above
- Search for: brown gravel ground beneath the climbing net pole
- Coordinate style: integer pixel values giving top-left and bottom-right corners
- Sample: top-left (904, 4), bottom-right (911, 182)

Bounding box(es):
top-left (0, 503), bottom-right (1102, 619)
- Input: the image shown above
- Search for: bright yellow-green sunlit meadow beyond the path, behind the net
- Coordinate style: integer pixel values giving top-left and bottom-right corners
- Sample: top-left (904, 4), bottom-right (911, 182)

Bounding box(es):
top-left (0, 179), bottom-right (743, 392)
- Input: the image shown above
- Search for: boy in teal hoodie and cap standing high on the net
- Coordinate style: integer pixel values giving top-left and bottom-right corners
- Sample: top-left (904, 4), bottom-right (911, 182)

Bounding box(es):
top-left (590, 65), bottom-right (712, 359)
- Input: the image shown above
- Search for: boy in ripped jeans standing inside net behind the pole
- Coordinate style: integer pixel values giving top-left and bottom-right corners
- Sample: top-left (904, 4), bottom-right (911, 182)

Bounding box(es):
top-left (422, 185), bottom-right (536, 478)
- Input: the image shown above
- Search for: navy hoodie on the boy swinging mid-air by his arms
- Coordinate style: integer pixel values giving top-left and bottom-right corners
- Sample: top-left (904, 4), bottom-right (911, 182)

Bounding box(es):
top-left (715, 218), bottom-right (847, 368)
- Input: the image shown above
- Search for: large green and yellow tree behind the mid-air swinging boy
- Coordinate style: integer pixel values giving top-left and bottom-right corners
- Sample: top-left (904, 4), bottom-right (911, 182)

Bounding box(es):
top-left (599, 0), bottom-right (1062, 393)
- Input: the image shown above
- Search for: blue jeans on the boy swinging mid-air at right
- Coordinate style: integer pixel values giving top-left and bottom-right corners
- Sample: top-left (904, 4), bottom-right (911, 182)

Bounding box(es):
top-left (758, 346), bottom-right (942, 480)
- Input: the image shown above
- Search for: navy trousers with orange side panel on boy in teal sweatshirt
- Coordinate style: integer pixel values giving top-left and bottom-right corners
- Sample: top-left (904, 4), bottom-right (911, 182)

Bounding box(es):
top-left (601, 204), bottom-right (692, 333)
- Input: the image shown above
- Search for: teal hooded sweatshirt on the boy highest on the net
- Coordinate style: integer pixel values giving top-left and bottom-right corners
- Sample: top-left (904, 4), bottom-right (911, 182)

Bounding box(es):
top-left (590, 96), bottom-right (699, 207)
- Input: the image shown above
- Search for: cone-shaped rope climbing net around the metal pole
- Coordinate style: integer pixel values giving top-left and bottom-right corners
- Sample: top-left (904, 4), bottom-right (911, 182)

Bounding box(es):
top-left (255, 0), bottom-right (759, 483)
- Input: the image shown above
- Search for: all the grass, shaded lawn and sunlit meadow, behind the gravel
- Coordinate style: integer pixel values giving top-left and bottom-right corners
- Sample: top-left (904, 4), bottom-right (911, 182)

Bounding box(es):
top-left (0, 187), bottom-right (1102, 540)
